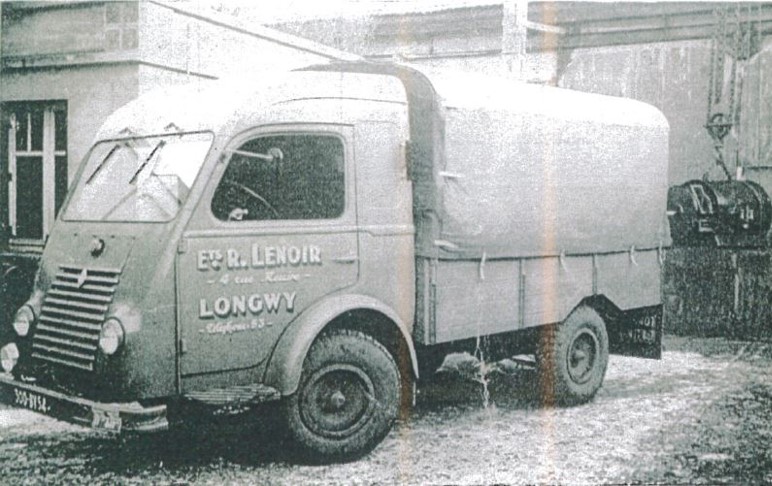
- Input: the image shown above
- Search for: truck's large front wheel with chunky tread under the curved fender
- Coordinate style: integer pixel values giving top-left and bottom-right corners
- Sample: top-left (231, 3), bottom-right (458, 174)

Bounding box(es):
top-left (283, 330), bottom-right (401, 463)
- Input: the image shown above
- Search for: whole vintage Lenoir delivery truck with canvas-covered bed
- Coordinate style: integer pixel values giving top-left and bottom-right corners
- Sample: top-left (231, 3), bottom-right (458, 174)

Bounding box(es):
top-left (0, 63), bottom-right (668, 460)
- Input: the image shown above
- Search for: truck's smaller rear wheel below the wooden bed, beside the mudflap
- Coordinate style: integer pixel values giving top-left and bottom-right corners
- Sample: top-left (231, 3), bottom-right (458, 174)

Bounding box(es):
top-left (536, 307), bottom-right (608, 406)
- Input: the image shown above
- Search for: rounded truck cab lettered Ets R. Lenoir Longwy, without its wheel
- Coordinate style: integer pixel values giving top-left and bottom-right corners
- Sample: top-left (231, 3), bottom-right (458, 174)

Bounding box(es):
top-left (5, 72), bottom-right (414, 456)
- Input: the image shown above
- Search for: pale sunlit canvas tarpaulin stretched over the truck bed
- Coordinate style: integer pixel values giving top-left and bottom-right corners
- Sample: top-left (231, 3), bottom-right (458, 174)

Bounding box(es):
top-left (413, 70), bottom-right (668, 259)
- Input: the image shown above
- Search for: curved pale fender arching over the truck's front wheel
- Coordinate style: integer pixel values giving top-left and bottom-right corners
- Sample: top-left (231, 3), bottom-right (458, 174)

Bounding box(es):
top-left (263, 295), bottom-right (418, 396)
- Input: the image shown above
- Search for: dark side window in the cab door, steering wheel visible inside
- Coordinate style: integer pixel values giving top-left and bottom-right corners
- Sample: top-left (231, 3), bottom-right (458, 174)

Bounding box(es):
top-left (212, 134), bottom-right (345, 221)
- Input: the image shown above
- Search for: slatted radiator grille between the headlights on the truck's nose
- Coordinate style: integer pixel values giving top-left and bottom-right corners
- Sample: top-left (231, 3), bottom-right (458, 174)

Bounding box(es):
top-left (32, 265), bottom-right (120, 371)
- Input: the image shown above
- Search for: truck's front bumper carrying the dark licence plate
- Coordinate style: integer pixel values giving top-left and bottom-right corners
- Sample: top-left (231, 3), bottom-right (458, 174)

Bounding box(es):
top-left (0, 373), bottom-right (169, 432)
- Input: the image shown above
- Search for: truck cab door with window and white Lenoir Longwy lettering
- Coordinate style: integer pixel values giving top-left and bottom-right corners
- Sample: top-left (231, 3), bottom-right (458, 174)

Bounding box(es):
top-left (177, 126), bottom-right (359, 376)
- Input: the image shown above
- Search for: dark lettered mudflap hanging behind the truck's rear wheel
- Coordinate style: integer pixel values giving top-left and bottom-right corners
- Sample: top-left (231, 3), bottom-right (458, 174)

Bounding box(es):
top-left (606, 305), bottom-right (663, 359)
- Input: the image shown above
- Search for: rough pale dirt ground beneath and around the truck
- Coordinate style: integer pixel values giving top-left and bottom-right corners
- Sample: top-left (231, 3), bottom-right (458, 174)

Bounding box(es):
top-left (0, 337), bottom-right (772, 485)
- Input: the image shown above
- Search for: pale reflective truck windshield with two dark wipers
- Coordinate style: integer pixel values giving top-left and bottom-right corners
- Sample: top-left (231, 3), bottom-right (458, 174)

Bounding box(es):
top-left (64, 133), bottom-right (212, 222)
